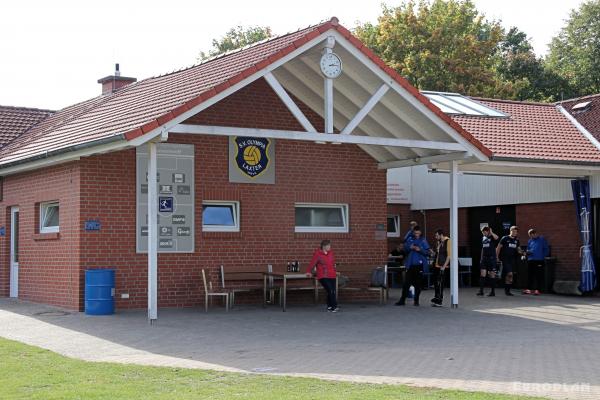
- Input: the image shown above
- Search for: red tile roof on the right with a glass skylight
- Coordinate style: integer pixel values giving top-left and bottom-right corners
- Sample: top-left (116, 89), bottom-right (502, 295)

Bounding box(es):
top-left (452, 99), bottom-right (600, 163)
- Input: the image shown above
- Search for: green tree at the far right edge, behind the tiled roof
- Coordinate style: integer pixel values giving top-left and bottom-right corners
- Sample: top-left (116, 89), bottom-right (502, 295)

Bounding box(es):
top-left (547, 0), bottom-right (600, 96)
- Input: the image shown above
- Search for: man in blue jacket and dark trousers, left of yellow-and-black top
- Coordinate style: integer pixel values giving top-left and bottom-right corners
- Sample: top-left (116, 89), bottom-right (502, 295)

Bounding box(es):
top-left (395, 225), bottom-right (429, 306)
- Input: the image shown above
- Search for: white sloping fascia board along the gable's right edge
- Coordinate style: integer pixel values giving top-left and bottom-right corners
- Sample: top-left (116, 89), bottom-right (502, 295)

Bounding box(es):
top-left (330, 31), bottom-right (489, 161)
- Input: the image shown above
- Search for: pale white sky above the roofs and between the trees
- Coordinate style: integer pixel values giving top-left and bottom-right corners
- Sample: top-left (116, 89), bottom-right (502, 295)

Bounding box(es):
top-left (0, 0), bottom-right (583, 110)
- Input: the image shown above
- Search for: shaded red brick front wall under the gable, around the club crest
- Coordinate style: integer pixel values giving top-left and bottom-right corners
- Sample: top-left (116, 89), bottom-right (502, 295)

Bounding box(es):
top-left (79, 80), bottom-right (387, 308)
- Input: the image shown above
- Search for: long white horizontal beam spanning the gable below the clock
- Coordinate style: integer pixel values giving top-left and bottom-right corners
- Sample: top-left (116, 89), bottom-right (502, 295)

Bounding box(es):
top-left (169, 124), bottom-right (464, 151)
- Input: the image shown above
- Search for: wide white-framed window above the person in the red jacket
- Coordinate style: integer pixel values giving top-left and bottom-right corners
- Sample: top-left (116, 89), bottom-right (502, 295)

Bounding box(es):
top-left (296, 203), bottom-right (349, 233)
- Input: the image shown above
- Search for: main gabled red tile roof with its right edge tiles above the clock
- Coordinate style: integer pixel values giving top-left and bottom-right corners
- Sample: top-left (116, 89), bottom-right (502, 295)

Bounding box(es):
top-left (0, 17), bottom-right (491, 165)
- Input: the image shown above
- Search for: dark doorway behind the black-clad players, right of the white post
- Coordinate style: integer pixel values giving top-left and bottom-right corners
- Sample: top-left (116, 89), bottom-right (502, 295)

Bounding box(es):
top-left (469, 205), bottom-right (516, 284)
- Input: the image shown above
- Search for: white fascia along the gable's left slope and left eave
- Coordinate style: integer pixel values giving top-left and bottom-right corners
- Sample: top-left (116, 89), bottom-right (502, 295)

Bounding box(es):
top-left (0, 31), bottom-right (331, 176)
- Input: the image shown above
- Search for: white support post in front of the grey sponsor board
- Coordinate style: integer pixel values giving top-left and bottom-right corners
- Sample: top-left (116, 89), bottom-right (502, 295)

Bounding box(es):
top-left (148, 142), bottom-right (158, 323)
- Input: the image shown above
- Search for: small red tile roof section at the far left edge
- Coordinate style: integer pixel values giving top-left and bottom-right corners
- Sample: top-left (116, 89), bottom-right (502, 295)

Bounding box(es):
top-left (0, 106), bottom-right (54, 148)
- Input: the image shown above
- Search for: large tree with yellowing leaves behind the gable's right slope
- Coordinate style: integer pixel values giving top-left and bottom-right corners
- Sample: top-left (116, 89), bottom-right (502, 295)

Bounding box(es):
top-left (355, 0), bottom-right (519, 98)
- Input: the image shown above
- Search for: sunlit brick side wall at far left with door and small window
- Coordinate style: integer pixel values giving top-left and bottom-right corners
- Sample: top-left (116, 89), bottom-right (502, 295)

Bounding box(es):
top-left (0, 162), bottom-right (80, 309)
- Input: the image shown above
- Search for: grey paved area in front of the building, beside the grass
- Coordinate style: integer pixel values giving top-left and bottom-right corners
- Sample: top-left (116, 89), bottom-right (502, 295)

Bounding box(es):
top-left (0, 289), bottom-right (600, 399)
